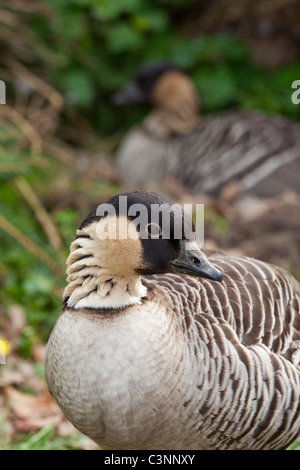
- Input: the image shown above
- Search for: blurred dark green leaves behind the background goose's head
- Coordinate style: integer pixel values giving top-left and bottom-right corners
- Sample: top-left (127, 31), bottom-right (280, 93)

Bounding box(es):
top-left (19, 0), bottom-right (300, 136)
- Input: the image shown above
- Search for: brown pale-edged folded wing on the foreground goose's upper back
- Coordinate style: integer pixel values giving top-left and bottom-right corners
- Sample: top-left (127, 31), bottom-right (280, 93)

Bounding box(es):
top-left (144, 254), bottom-right (300, 358)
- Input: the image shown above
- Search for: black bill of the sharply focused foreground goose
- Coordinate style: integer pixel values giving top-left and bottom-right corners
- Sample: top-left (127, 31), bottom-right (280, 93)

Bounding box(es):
top-left (171, 242), bottom-right (223, 282)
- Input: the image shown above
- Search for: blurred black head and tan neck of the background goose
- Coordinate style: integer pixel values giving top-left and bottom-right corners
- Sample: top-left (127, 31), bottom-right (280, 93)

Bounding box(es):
top-left (112, 62), bottom-right (200, 135)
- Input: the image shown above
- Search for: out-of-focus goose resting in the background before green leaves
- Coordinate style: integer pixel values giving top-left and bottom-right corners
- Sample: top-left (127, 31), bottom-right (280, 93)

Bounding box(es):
top-left (113, 64), bottom-right (300, 197)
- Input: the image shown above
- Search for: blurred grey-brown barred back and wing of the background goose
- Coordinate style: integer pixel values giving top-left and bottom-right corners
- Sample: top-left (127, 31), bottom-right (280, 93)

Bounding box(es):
top-left (165, 112), bottom-right (300, 197)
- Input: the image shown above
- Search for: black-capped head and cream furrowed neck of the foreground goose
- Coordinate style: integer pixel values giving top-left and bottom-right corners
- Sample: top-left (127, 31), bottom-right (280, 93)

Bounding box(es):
top-left (63, 191), bottom-right (222, 308)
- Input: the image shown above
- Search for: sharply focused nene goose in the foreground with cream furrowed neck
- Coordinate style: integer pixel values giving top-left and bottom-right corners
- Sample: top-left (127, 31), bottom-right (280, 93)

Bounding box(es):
top-left (45, 191), bottom-right (300, 450)
